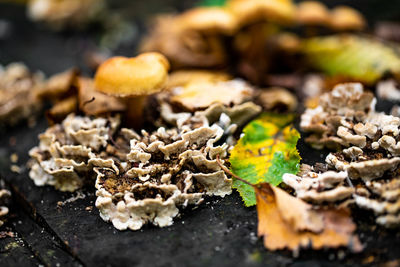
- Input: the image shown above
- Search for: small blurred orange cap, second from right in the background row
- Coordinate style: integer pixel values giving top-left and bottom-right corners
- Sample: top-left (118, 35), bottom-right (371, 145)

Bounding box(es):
top-left (296, 1), bottom-right (330, 25)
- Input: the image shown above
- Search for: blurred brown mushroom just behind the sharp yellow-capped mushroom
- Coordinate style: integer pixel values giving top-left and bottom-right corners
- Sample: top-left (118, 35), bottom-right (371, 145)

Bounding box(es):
top-left (140, 15), bottom-right (228, 69)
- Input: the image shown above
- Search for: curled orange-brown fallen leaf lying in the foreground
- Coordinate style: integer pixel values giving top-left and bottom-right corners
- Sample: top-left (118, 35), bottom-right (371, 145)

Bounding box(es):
top-left (256, 183), bottom-right (362, 252)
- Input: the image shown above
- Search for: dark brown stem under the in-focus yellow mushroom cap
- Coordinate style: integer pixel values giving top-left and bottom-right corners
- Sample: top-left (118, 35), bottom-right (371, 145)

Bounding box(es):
top-left (125, 96), bottom-right (147, 130)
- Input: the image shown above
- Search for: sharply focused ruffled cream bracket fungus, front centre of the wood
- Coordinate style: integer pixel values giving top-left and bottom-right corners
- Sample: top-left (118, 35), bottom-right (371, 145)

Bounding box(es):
top-left (95, 121), bottom-right (232, 230)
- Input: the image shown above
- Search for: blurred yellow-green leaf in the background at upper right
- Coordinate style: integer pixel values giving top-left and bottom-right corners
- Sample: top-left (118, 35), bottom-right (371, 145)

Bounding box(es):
top-left (301, 35), bottom-right (400, 84)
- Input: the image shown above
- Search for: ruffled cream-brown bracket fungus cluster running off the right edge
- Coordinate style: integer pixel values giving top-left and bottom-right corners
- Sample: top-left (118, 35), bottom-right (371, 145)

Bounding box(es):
top-left (283, 83), bottom-right (400, 227)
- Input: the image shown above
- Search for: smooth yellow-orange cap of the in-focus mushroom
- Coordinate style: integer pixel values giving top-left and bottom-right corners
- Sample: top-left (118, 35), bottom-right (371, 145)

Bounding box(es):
top-left (95, 52), bottom-right (169, 97)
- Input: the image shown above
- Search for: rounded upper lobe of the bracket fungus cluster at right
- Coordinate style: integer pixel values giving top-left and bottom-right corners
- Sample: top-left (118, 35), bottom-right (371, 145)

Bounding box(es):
top-left (300, 83), bottom-right (380, 151)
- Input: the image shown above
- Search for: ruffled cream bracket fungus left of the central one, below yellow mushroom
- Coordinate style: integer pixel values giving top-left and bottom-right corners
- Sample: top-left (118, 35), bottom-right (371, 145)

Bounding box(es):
top-left (29, 115), bottom-right (119, 191)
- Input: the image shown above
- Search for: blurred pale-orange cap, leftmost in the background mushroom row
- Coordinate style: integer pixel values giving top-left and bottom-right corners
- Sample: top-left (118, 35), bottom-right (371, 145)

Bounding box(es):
top-left (177, 7), bottom-right (237, 34)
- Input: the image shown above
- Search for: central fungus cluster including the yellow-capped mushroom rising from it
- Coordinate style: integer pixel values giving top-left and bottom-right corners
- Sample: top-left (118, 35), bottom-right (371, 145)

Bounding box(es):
top-left (30, 53), bottom-right (272, 230)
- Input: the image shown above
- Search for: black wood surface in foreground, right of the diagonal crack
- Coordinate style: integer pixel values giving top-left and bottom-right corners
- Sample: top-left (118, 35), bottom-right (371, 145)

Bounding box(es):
top-left (0, 115), bottom-right (400, 266)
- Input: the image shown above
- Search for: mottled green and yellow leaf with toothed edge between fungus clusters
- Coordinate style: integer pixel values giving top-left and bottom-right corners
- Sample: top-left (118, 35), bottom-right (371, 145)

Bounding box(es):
top-left (229, 113), bottom-right (301, 206)
